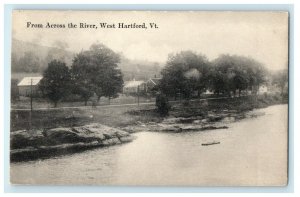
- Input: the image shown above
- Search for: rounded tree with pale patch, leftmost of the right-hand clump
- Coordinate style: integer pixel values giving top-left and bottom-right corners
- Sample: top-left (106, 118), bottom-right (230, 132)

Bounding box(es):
top-left (160, 51), bottom-right (209, 99)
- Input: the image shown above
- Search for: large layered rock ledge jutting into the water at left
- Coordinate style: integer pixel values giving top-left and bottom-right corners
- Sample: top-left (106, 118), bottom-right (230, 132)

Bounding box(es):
top-left (10, 123), bottom-right (134, 161)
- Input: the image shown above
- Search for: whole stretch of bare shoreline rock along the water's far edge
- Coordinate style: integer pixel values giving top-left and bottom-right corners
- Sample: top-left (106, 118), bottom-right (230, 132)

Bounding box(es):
top-left (10, 107), bottom-right (264, 162)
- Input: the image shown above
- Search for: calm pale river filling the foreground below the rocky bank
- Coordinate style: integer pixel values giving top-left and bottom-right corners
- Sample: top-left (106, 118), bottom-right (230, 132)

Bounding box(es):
top-left (10, 105), bottom-right (288, 186)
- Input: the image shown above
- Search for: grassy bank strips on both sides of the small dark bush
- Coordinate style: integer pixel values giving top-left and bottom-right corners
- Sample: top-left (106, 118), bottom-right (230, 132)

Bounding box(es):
top-left (11, 95), bottom-right (287, 131)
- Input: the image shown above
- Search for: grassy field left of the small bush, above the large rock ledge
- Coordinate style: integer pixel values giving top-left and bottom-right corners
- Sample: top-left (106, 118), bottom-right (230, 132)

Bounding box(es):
top-left (11, 105), bottom-right (160, 131)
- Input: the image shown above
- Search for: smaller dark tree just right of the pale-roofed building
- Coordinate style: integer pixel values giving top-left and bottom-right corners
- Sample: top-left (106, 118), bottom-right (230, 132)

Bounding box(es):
top-left (39, 60), bottom-right (71, 107)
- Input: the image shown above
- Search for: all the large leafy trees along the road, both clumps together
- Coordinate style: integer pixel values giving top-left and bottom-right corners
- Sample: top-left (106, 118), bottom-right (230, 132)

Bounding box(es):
top-left (39, 44), bottom-right (288, 106)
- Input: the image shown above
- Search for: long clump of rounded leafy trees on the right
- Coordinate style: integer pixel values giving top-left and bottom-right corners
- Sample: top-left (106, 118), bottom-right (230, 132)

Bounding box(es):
top-left (160, 51), bottom-right (287, 99)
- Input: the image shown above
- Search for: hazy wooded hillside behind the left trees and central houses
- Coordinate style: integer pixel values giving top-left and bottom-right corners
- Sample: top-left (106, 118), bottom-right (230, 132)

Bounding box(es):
top-left (11, 39), bottom-right (162, 81)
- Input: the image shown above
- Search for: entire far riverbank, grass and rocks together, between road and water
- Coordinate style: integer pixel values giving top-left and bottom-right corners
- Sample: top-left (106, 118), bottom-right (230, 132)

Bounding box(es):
top-left (10, 96), bottom-right (283, 161)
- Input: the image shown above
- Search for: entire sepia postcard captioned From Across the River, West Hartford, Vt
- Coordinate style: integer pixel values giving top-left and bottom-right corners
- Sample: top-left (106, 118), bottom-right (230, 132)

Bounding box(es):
top-left (10, 10), bottom-right (289, 186)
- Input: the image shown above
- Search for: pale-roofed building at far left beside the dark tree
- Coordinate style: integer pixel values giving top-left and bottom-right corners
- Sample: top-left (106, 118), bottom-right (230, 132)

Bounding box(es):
top-left (18, 77), bottom-right (43, 97)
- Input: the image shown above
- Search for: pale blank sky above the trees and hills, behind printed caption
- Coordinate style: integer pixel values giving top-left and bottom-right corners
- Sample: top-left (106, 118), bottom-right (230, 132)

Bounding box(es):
top-left (12, 10), bottom-right (288, 70)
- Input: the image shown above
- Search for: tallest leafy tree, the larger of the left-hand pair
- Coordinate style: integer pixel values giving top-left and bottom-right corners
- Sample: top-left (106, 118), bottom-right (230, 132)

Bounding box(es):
top-left (71, 44), bottom-right (123, 105)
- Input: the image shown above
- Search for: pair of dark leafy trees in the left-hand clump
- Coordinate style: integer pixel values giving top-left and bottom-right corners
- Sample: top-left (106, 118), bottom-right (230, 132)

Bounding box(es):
top-left (39, 44), bottom-right (123, 107)
